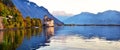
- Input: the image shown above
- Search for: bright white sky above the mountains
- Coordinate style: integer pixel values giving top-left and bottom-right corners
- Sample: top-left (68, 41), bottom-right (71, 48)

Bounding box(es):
top-left (29, 0), bottom-right (120, 16)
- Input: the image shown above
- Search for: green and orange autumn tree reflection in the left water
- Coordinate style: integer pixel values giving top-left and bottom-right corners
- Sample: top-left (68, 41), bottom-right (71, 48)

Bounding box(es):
top-left (0, 28), bottom-right (42, 50)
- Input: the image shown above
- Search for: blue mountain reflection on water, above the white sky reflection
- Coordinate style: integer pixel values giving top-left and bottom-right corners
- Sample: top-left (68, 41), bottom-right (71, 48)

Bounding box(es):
top-left (56, 26), bottom-right (120, 41)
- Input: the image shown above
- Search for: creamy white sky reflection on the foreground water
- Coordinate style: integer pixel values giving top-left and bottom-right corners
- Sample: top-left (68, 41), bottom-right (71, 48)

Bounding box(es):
top-left (37, 35), bottom-right (120, 50)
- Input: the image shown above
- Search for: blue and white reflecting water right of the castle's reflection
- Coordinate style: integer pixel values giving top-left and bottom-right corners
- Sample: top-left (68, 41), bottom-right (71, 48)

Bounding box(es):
top-left (37, 26), bottom-right (120, 50)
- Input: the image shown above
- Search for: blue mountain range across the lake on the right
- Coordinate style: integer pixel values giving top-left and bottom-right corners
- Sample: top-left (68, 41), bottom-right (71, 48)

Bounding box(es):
top-left (64, 10), bottom-right (120, 24)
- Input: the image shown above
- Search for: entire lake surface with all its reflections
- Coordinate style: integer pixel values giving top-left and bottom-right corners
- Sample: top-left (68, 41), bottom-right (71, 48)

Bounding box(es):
top-left (0, 26), bottom-right (120, 50)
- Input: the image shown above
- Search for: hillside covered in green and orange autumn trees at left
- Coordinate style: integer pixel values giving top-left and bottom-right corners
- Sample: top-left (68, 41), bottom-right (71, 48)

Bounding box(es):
top-left (0, 0), bottom-right (42, 29)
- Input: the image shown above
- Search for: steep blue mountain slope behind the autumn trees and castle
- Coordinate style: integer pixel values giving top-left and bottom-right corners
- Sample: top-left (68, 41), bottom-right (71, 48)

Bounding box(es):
top-left (12, 0), bottom-right (63, 24)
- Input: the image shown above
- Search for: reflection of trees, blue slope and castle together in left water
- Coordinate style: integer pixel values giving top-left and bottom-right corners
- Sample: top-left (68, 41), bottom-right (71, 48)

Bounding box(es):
top-left (0, 27), bottom-right (54, 50)
